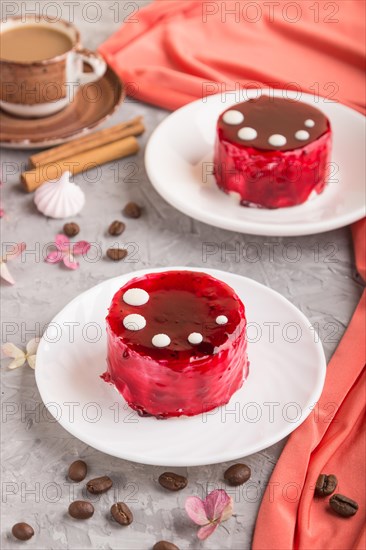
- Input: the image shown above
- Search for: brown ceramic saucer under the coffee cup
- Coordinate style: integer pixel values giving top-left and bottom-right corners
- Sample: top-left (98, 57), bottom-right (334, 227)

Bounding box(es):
top-left (0, 67), bottom-right (125, 149)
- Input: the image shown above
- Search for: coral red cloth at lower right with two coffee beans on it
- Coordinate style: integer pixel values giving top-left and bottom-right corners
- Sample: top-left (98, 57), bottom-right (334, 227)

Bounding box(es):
top-left (252, 291), bottom-right (366, 550)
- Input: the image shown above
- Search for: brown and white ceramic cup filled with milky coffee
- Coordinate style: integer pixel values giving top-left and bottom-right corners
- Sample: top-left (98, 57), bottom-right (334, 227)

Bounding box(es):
top-left (0, 16), bottom-right (107, 118)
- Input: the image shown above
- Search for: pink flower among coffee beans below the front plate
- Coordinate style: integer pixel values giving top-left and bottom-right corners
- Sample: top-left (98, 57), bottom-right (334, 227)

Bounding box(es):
top-left (185, 489), bottom-right (233, 540)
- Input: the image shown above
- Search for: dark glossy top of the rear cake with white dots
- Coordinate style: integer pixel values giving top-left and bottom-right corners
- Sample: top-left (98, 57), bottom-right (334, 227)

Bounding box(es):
top-left (218, 95), bottom-right (329, 151)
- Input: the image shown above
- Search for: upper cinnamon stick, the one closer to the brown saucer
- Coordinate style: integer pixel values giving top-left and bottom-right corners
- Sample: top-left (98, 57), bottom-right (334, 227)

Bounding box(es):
top-left (29, 117), bottom-right (145, 168)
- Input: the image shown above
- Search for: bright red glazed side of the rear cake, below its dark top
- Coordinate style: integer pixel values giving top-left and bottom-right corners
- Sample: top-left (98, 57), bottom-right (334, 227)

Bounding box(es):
top-left (214, 130), bottom-right (331, 208)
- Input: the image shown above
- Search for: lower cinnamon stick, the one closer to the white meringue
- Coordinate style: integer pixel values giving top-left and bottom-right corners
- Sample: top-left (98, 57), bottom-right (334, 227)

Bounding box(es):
top-left (21, 136), bottom-right (139, 193)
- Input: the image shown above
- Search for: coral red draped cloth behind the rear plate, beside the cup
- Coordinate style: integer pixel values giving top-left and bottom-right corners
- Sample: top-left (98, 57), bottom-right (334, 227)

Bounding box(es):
top-left (99, 0), bottom-right (365, 111)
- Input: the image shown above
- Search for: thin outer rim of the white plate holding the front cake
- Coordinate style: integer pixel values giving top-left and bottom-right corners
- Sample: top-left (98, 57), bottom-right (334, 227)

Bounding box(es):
top-left (35, 266), bottom-right (327, 467)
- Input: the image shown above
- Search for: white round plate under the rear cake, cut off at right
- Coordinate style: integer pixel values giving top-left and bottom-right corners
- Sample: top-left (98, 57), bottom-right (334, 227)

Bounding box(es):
top-left (145, 90), bottom-right (366, 236)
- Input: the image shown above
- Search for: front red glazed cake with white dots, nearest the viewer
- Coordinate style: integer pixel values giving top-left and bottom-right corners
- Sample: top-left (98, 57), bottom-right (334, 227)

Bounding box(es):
top-left (103, 271), bottom-right (248, 418)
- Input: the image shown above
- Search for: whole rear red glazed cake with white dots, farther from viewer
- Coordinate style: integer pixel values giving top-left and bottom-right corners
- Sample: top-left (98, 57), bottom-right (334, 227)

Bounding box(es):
top-left (214, 95), bottom-right (332, 208)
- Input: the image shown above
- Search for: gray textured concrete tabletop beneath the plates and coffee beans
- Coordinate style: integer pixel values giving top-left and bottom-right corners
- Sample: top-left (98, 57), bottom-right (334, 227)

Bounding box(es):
top-left (1, 1), bottom-right (361, 550)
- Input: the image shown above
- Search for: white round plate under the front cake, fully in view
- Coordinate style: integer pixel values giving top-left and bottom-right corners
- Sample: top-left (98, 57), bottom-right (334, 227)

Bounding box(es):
top-left (36, 267), bottom-right (326, 466)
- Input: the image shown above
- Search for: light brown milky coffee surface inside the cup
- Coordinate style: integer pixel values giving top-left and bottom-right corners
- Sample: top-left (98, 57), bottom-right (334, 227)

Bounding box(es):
top-left (0, 25), bottom-right (73, 63)
